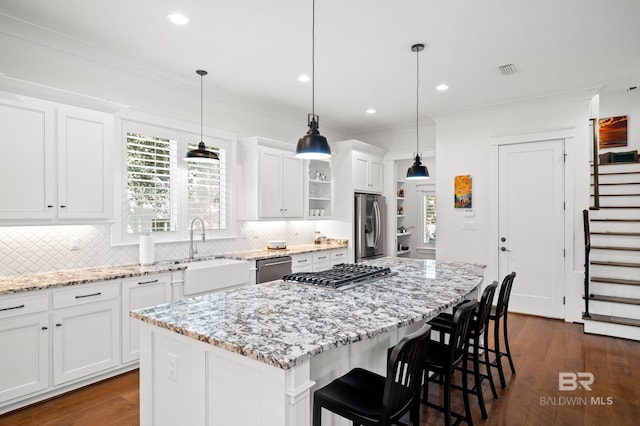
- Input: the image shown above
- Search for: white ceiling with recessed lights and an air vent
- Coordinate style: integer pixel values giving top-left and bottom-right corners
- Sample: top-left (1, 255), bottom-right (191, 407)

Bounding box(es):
top-left (0, 0), bottom-right (640, 134)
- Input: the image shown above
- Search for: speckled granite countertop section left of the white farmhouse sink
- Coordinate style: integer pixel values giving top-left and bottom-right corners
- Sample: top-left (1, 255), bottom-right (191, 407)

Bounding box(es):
top-left (0, 263), bottom-right (186, 295)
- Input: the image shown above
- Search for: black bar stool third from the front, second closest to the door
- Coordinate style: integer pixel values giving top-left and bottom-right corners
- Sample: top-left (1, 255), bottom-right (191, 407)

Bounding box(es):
top-left (429, 281), bottom-right (498, 420)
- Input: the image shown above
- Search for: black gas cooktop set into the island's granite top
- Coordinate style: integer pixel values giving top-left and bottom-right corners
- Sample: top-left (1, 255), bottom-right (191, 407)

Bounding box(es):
top-left (282, 263), bottom-right (395, 290)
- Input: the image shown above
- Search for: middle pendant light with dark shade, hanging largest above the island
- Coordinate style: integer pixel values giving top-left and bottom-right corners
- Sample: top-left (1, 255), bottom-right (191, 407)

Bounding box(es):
top-left (296, 0), bottom-right (331, 160)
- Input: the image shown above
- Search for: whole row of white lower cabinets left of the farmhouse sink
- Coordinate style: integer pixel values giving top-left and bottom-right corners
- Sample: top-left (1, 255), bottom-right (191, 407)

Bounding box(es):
top-left (0, 273), bottom-right (172, 412)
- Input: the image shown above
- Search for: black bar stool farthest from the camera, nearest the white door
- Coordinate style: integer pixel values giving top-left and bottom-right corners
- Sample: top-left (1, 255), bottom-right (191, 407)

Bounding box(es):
top-left (485, 272), bottom-right (516, 389)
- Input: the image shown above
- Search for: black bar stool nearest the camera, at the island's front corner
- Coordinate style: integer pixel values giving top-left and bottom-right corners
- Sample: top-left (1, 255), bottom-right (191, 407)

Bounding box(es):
top-left (313, 325), bottom-right (431, 426)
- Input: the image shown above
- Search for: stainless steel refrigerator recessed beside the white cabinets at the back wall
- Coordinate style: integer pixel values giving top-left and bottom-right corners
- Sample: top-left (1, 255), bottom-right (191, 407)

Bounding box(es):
top-left (353, 194), bottom-right (386, 262)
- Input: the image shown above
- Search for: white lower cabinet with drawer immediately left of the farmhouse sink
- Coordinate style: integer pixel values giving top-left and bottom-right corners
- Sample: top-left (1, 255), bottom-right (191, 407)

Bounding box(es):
top-left (122, 274), bottom-right (171, 363)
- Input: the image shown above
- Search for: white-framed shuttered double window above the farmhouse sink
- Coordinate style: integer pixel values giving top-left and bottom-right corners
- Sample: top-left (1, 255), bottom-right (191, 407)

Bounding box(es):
top-left (114, 122), bottom-right (233, 244)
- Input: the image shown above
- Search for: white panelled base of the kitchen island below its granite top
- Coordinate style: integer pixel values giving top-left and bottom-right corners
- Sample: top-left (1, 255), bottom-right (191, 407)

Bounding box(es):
top-left (140, 322), bottom-right (315, 426)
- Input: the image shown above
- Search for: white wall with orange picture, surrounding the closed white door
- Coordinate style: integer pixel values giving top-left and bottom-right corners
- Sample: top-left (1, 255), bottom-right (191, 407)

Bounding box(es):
top-left (436, 93), bottom-right (593, 320)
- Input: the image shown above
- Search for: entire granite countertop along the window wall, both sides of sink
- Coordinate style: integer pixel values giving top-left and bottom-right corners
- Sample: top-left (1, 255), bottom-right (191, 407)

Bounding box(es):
top-left (0, 242), bottom-right (347, 296)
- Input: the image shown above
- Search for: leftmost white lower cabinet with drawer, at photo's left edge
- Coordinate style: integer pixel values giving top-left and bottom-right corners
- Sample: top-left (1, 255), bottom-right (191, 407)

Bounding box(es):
top-left (0, 294), bottom-right (49, 403)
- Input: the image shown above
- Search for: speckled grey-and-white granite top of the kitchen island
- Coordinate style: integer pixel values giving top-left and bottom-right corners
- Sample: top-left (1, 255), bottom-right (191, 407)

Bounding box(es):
top-left (131, 258), bottom-right (484, 369)
